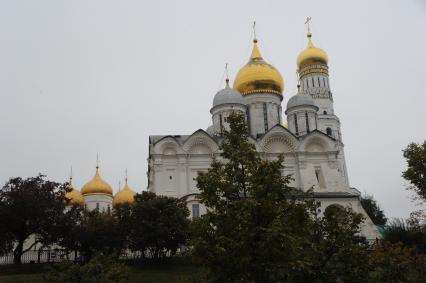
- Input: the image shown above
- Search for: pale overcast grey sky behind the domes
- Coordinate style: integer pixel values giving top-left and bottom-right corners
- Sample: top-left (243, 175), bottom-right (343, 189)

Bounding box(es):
top-left (0, 0), bottom-right (426, 220)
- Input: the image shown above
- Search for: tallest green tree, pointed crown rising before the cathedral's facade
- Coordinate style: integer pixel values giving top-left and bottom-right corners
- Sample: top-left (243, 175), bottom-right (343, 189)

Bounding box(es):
top-left (192, 113), bottom-right (314, 282)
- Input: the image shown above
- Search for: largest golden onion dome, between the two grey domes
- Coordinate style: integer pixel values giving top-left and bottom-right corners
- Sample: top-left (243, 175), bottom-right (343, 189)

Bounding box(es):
top-left (234, 38), bottom-right (284, 96)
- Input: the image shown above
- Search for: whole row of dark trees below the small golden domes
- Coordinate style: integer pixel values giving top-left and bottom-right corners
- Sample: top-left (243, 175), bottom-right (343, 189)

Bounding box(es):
top-left (0, 175), bottom-right (189, 264)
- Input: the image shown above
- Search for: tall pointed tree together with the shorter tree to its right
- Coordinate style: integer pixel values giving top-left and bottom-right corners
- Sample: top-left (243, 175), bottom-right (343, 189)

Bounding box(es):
top-left (193, 114), bottom-right (367, 282)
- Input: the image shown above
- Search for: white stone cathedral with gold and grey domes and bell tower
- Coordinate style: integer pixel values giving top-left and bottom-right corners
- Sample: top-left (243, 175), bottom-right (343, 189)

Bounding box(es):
top-left (148, 26), bottom-right (380, 240)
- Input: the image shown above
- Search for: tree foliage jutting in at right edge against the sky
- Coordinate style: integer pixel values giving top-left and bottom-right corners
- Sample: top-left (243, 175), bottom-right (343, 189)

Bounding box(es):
top-left (402, 141), bottom-right (426, 201)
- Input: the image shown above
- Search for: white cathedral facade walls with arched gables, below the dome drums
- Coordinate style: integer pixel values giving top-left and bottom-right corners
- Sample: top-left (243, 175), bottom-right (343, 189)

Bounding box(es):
top-left (149, 126), bottom-right (349, 197)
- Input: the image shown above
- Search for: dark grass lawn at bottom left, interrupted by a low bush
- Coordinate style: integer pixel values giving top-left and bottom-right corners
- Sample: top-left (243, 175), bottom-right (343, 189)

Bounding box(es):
top-left (0, 261), bottom-right (199, 283)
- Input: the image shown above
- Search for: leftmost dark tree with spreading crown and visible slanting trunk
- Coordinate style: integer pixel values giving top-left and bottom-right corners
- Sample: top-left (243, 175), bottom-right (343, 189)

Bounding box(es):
top-left (0, 175), bottom-right (67, 264)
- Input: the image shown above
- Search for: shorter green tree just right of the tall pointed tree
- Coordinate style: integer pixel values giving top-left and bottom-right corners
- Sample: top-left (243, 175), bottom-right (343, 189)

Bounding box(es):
top-left (296, 205), bottom-right (369, 283)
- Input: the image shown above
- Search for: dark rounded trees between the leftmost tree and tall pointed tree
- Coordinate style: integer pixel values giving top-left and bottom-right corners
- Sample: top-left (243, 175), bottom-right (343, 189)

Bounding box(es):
top-left (61, 192), bottom-right (189, 261)
